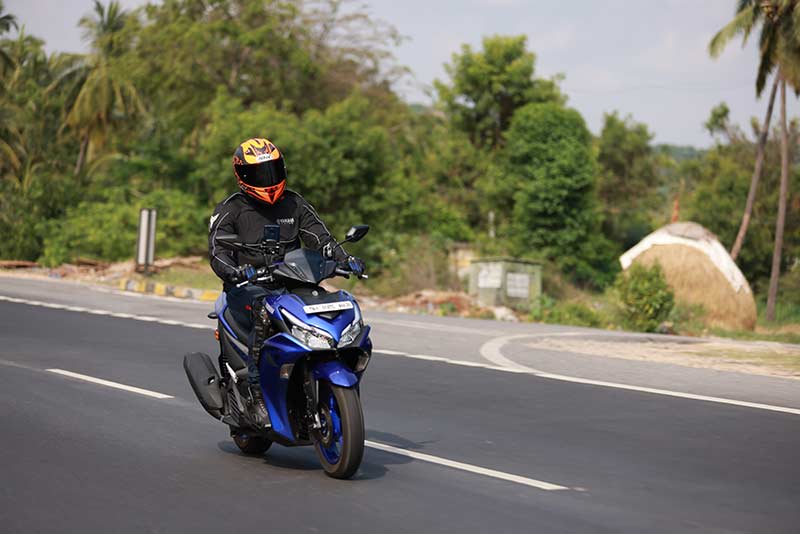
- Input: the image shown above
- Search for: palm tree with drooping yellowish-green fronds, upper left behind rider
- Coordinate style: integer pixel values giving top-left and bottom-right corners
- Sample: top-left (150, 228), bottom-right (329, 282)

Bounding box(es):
top-left (50, 0), bottom-right (144, 175)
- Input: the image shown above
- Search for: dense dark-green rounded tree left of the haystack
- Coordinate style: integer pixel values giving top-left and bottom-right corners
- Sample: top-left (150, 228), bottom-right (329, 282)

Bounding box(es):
top-left (496, 104), bottom-right (616, 287)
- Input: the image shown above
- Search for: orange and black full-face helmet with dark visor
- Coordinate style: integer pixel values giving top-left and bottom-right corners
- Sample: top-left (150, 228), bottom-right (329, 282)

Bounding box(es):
top-left (233, 137), bottom-right (286, 204)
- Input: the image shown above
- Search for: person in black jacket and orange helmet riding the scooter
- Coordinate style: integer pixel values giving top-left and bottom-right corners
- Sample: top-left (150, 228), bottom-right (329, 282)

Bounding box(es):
top-left (208, 138), bottom-right (364, 427)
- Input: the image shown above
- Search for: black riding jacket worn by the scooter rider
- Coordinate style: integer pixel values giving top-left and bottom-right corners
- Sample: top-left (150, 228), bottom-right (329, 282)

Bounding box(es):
top-left (208, 190), bottom-right (347, 288)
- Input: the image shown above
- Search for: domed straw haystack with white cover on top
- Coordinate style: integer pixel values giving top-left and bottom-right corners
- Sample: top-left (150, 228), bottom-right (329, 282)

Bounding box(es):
top-left (619, 222), bottom-right (756, 330)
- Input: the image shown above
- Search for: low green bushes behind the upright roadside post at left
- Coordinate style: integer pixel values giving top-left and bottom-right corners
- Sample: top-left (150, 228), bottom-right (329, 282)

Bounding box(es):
top-left (40, 190), bottom-right (207, 266)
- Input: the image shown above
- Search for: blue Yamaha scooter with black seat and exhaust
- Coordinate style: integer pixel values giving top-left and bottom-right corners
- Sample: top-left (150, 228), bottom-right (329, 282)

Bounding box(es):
top-left (183, 225), bottom-right (372, 479)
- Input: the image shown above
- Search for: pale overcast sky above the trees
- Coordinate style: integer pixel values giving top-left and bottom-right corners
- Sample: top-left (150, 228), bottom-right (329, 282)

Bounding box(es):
top-left (5, 0), bottom-right (780, 146)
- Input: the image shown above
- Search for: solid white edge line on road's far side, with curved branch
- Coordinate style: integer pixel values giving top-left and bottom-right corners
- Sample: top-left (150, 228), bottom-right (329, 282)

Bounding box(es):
top-left (0, 295), bottom-right (800, 415)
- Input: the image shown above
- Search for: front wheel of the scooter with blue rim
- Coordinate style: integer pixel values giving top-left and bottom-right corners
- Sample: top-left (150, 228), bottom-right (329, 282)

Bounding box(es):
top-left (314, 382), bottom-right (364, 478)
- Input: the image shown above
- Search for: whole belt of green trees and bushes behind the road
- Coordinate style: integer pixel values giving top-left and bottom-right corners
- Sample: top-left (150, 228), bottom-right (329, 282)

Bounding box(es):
top-left (0, 0), bottom-right (800, 314)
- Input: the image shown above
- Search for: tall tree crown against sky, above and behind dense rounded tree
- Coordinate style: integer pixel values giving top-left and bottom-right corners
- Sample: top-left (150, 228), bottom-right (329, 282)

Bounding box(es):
top-left (434, 35), bottom-right (566, 149)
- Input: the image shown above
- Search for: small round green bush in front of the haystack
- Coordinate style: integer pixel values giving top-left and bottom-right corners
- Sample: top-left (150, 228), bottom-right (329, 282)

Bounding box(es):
top-left (614, 263), bottom-right (675, 332)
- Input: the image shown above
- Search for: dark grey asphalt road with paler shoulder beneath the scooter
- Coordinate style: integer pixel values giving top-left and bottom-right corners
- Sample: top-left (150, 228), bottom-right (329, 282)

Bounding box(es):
top-left (0, 279), bottom-right (800, 533)
